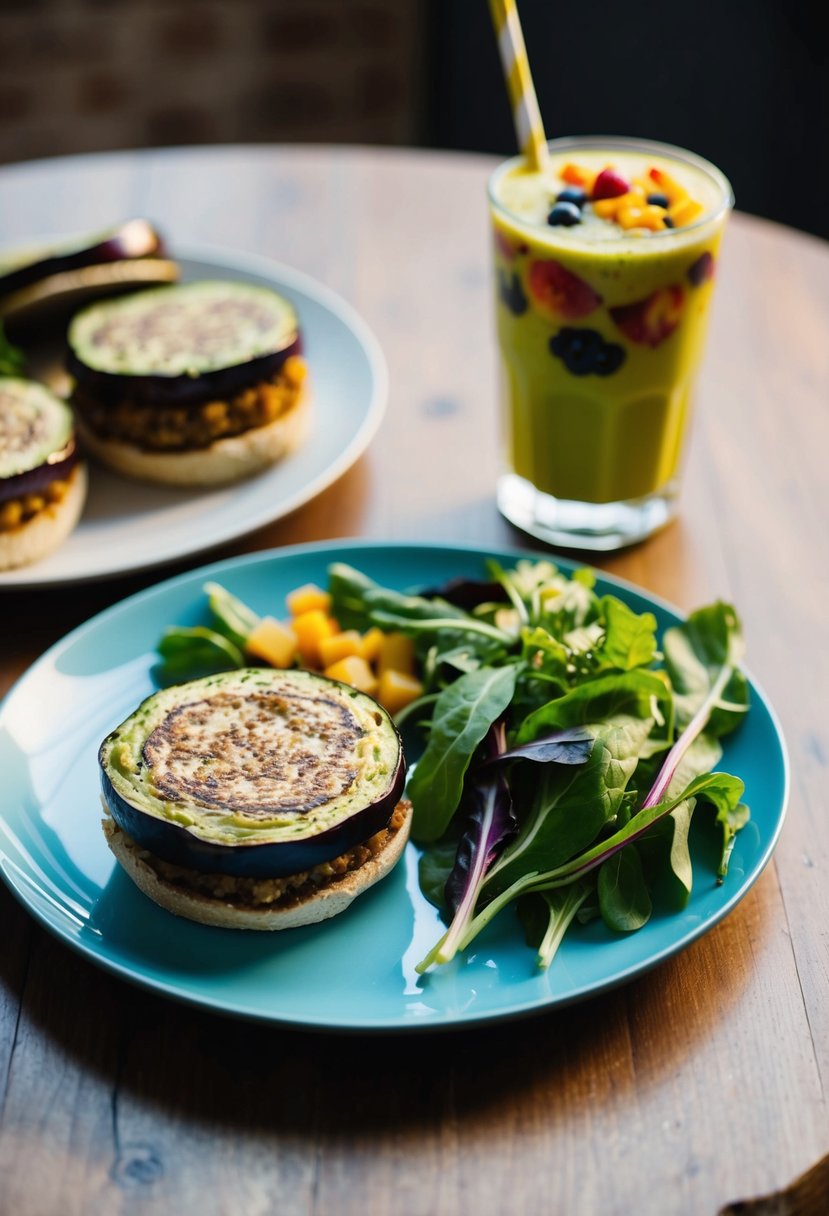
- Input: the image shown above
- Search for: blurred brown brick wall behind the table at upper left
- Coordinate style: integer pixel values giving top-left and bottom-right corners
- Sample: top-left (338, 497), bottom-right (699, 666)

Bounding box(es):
top-left (0, 0), bottom-right (424, 162)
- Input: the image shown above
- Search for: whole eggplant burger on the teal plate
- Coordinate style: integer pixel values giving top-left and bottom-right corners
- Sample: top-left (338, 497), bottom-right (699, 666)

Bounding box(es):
top-left (98, 669), bottom-right (411, 929)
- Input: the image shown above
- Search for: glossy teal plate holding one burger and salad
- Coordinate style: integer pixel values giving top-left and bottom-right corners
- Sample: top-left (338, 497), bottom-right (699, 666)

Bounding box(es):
top-left (0, 541), bottom-right (789, 1031)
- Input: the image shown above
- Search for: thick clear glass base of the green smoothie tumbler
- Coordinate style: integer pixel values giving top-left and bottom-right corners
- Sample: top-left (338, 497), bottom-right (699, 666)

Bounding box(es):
top-left (497, 473), bottom-right (679, 550)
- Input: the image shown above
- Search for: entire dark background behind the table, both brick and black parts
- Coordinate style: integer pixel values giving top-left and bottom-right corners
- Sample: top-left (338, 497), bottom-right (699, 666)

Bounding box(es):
top-left (0, 0), bottom-right (829, 237)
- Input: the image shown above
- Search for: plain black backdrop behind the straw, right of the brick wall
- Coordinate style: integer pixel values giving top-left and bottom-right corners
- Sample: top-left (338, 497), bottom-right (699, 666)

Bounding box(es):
top-left (424, 0), bottom-right (829, 237)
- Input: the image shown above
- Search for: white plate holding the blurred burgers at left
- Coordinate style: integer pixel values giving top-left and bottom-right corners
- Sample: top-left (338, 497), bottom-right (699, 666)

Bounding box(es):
top-left (0, 248), bottom-right (388, 589)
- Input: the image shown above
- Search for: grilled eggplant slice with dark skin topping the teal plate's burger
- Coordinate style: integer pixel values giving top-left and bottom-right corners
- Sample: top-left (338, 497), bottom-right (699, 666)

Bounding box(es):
top-left (98, 669), bottom-right (406, 878)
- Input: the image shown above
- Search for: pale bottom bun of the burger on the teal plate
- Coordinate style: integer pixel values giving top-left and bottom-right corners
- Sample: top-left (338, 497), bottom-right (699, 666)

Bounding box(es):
top-left (102, 801), bottom-right (412, 930)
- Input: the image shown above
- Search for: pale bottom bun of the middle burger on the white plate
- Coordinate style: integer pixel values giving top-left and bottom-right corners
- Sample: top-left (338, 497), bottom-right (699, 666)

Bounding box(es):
top-left (78, 389), bottom-right (310, 486)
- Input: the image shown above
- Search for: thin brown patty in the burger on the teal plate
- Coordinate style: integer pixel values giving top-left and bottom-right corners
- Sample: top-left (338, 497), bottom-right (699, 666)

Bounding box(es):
top-left (106, 804), bottom-right (406, 908)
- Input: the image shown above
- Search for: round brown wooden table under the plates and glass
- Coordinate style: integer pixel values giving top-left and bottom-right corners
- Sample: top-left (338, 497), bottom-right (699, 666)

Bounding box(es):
top-left (0, 147), bottom-right (829, 1216)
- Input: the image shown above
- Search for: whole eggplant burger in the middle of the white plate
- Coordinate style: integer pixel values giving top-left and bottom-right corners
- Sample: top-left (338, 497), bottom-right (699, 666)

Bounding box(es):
top-left (68, 281), bottom-right (309, 485)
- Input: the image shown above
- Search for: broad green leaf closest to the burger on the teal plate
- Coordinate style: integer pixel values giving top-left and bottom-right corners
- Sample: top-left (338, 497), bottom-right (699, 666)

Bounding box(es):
top-left (408, 666), bottom-right (517, 843)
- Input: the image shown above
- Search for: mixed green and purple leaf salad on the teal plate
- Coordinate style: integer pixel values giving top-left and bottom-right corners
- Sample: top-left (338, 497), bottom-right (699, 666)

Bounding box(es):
top-left (151, 559), bottom-right (749, 972)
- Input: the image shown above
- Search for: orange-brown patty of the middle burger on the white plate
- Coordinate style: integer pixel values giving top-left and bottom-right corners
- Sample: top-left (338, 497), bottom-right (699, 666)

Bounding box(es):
top-left (72, 355), bottom-right (308, 452)
